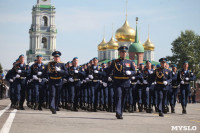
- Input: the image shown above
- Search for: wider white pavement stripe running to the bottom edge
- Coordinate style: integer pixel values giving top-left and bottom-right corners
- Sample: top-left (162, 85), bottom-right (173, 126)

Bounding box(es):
top-left (0, 109), bottom-right (17, 133)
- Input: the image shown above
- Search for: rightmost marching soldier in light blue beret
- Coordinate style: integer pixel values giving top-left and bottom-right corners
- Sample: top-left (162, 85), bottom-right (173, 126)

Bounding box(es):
top-left (178, 61), bottom-right (195, 114)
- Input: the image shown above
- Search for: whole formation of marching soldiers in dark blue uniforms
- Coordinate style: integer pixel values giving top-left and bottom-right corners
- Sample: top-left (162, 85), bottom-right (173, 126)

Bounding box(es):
top-left (6, 46), bottom-right (195, 119)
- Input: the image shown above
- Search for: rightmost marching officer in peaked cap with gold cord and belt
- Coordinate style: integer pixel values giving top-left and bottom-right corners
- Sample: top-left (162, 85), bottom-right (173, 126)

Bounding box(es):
top-left (154, 58), bottom-right (172, 117)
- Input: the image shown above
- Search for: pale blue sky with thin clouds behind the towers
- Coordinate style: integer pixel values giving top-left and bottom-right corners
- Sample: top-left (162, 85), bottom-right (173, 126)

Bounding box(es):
top-left (0, 0), bottom-right (200, 69)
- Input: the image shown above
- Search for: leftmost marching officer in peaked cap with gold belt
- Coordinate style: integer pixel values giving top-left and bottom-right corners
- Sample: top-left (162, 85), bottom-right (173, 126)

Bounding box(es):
top-left (46, 51), bottom-right (68, 114)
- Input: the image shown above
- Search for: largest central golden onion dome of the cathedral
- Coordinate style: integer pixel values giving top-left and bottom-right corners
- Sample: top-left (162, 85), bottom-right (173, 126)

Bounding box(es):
top-left (115, 20), bottom-right (135, 42)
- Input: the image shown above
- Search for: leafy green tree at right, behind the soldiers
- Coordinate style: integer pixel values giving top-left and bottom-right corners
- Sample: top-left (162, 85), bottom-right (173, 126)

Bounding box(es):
top-left (167, 30), bottom-right (200, 78)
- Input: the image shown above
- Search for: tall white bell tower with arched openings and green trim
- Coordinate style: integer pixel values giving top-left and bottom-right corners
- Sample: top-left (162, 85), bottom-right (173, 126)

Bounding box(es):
top-left (26, 0), bottom-right (57, 63)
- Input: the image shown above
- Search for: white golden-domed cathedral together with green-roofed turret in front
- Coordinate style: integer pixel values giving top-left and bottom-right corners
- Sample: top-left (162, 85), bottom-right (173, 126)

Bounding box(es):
top-left (98, 17), bottom-right (155, 64)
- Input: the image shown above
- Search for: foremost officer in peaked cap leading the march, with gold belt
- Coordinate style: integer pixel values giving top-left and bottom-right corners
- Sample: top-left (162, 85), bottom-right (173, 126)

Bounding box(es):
top-left (107, 46), bottom-right (135, 119)
